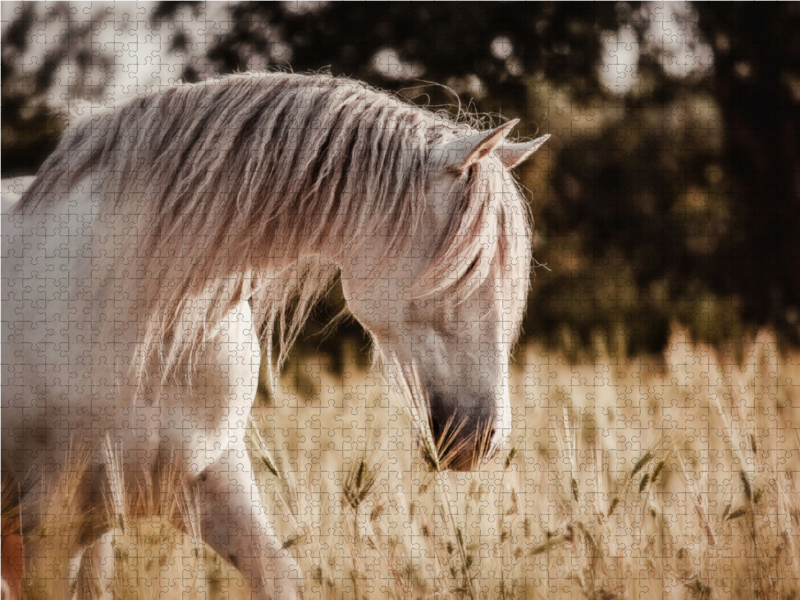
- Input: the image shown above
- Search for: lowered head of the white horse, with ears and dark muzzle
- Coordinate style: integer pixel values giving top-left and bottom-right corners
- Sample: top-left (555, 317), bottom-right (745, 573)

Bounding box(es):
top-left (342, 121), bottom-right (548, 470)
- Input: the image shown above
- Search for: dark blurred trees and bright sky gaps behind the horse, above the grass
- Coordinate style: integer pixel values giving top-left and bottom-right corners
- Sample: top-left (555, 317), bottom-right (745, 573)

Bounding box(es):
top-left (6, 2), bottom-right (800, 364)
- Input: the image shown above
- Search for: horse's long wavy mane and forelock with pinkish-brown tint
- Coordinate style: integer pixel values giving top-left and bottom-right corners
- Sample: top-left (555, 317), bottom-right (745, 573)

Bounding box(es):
top-left (17, 73), bottom-right (530, 390)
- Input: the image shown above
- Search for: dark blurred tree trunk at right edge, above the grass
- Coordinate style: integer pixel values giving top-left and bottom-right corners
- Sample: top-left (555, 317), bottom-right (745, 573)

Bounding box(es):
top-left (697, 2), bottom-right (800, 342)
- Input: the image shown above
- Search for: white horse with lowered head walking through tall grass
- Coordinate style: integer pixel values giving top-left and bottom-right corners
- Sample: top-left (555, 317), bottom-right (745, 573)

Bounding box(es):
top-left (2, 73), bottom-right (547, 598)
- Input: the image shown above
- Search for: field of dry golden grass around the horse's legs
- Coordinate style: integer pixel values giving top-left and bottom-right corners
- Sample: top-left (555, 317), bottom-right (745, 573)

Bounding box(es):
top-left (4, 330), bottom-right (800, 600)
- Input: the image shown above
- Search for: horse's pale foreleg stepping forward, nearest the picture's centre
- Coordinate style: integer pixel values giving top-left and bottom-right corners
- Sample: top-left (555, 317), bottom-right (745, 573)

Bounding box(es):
top-left (198, 450), bottom-right (299, 600)
